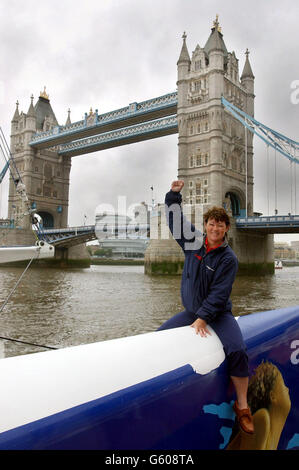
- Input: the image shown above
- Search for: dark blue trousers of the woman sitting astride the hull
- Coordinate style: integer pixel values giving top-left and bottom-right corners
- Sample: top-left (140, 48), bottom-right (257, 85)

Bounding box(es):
top-left (157, 310), bottom-right (249, 377)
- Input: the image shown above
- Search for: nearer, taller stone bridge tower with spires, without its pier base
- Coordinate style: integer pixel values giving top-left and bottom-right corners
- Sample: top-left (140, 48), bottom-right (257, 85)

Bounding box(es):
top-left (177, 17), bottom-right (254, 215)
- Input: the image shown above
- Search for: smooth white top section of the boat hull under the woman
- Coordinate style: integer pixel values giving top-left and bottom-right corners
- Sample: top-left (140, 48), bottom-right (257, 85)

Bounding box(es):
top-left (0, 326), bottom-right (225, 433)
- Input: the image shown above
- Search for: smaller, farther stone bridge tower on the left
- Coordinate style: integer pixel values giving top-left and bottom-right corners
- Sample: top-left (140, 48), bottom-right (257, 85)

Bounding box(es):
top-left (8, 89), bottom-right (71, 228)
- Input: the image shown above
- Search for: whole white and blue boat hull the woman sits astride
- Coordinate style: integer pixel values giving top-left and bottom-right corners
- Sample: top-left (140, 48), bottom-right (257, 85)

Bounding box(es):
top-left (0, 306), bottom-right (299, 450)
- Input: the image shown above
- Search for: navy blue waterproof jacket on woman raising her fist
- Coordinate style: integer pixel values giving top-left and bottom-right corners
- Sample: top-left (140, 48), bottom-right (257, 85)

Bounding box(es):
top-left (165, 191), bottom-right (238, 323)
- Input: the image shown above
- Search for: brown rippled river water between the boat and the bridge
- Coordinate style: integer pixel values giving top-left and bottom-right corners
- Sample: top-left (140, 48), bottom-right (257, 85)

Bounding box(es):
top-left (0, 265), bottom-right (299, 357)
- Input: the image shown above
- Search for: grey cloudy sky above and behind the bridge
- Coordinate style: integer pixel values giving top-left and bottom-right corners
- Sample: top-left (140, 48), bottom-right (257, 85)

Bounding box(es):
top-left (0, 0), bottom-right (299, 240)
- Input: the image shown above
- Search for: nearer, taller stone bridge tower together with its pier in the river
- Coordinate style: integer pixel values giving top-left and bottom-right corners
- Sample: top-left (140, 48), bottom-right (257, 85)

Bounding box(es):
top-left (145, 15), bottom-right (274, 274)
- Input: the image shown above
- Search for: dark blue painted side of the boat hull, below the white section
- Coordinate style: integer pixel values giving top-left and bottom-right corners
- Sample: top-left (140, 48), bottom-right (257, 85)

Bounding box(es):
top-left (0, 307), bottom-right (299, 450)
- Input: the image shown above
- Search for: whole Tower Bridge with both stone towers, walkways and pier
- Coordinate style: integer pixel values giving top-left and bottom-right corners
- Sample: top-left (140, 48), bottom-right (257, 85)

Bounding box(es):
top-left (2, 16), bottom-right (299, 274)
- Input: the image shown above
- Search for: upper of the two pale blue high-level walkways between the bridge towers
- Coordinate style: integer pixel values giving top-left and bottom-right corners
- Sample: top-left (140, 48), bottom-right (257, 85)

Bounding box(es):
top-left (30, 92), bottom-right (177, 151)
